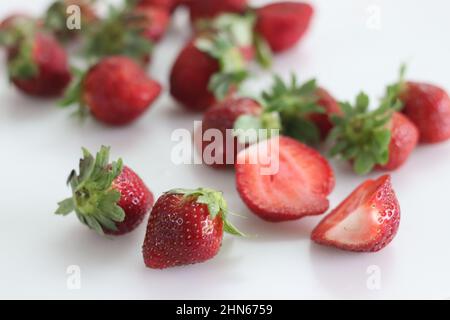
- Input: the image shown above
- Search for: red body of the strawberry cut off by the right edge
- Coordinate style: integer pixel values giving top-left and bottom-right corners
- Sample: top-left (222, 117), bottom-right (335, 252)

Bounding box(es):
top-left (400, 82), bottom-right (450, 143)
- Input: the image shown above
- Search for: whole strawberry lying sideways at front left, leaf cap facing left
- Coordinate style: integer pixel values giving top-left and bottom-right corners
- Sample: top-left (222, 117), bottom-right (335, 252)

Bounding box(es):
top-left (56, 146), bottom-right (153, 236)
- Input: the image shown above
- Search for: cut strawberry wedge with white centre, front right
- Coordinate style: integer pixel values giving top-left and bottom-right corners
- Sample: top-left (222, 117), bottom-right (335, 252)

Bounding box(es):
top-left (311, 175), bottom-right (400, 252)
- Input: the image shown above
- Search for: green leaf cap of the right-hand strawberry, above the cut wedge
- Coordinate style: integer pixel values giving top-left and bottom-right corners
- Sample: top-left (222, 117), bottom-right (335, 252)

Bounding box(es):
top-left (329, 92), bottom-right (401, 175)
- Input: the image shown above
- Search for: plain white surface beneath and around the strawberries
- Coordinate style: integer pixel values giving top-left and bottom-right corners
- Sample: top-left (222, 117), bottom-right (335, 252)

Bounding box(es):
top-left (0, 0), bottom-right (450, 299)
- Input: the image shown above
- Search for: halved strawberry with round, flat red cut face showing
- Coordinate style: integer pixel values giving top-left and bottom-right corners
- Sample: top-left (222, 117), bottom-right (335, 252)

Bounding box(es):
top-left (236, 136), bottom-right (334, 222)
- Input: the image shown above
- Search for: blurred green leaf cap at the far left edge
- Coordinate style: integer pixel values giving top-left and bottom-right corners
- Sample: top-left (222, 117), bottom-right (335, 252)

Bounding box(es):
top-left (0, 17), bottom-right (39, 79)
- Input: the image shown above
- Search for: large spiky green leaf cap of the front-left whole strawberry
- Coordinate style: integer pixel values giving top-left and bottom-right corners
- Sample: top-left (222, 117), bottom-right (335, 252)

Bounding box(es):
top-left (55, 146), bottom-right (125, 235)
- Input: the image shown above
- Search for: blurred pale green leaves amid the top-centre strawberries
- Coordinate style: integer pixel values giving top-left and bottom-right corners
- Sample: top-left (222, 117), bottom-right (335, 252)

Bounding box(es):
top-left (196, 14), bottom-right (271, 100)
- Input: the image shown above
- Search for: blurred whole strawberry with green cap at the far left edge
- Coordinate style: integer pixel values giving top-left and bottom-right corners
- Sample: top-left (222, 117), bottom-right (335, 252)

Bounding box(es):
top-left (2, 19), bottom-right (71, 97)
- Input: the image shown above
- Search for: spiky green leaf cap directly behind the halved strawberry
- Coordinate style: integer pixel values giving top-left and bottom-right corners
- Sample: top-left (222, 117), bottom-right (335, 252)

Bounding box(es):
top-left (262, 74), bottom-right (325, 145)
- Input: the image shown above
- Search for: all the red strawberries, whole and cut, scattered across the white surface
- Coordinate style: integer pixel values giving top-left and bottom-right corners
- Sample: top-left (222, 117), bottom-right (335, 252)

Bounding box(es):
top-left (0, 0), bottom-right (450, 269)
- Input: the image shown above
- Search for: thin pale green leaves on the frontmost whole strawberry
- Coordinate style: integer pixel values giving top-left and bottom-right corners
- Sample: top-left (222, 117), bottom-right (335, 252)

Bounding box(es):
top-left (167, 188), bottom-right (245, 236)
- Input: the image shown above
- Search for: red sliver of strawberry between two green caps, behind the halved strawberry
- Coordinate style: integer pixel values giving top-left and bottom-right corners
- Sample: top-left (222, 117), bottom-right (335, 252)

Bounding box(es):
top-left (309, 88), bottom-right (342, 139)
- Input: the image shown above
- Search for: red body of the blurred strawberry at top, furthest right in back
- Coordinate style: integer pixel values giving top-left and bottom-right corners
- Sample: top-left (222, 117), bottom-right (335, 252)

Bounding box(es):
top-left (256, 1), bottom-right (314, 52)
